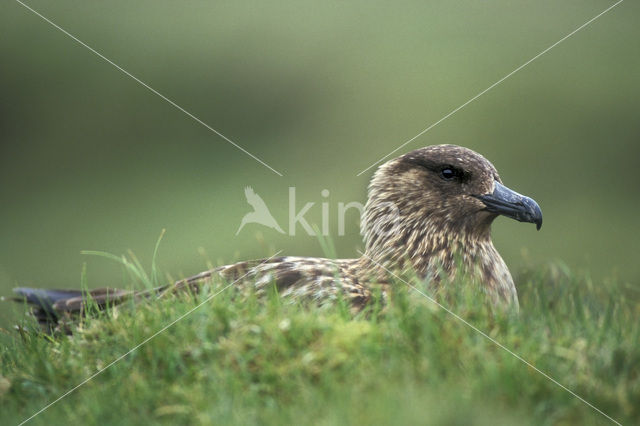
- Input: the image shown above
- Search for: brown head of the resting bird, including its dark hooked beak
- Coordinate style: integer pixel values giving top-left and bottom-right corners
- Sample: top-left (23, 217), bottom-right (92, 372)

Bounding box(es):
top-left (362, 145), bottom-right (542, 256)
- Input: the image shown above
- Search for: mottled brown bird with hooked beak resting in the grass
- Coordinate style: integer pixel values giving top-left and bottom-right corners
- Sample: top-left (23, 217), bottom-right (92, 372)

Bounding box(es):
top-left (14, 145), bottom-right (542, 330)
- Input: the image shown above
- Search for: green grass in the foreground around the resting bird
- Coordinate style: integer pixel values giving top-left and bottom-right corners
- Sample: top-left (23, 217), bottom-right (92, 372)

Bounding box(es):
top-left (0, 251), bottom-right (640, 425)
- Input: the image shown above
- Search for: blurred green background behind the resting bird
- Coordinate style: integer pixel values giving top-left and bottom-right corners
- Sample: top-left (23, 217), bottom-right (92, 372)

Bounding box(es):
top-left (0, 0), bottom-right (640, 322)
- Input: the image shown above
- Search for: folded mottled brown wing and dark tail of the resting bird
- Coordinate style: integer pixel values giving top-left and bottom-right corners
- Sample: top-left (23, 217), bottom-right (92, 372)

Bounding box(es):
top-left (13, 257), bottom-right (371, 334)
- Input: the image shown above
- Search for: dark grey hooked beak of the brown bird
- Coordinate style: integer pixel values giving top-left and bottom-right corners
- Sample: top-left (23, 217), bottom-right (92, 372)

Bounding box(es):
top-left (474, 181), bottom-right (542, 230)
